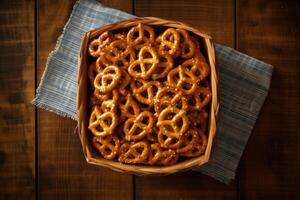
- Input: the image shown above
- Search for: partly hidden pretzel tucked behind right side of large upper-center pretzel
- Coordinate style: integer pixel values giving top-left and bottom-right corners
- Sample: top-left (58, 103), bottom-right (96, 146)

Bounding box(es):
top-left (151, 54), bottom-right (173, 80)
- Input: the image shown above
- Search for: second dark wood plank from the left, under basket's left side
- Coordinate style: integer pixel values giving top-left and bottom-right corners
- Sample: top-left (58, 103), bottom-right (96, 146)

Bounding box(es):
top-left (38, 0), bottom-right (133, 200)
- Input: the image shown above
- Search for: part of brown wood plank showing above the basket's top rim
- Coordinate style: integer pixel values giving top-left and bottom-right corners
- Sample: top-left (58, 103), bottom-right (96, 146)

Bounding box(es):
top-left (135, 0), bottom-right (234, 47)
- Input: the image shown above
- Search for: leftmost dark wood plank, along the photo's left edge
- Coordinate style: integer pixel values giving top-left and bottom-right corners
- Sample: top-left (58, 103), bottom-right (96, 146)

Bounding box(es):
top-left (0, 0), bottom-right (35, 199)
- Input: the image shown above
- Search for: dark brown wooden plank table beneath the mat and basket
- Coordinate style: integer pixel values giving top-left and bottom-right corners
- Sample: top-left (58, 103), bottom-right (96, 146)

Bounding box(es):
top-left (0, 0), bottom-right (300, 200)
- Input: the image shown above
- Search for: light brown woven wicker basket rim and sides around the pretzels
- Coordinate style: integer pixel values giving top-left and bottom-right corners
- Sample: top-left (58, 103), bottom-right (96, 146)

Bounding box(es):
top-left (77, 17), bottom-right (219, 175)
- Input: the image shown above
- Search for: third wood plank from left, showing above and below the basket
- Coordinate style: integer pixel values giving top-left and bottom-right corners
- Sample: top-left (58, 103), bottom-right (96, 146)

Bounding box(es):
top-left (135, 0), bottom-right (237, 200)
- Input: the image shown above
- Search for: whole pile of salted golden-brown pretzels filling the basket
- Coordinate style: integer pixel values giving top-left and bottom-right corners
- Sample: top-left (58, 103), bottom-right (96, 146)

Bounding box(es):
top-left (88, 23), bottom-right (211, 165)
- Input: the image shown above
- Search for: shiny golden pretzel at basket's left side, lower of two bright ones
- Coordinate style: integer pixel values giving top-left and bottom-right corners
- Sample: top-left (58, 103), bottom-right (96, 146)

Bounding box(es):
top-left (88, 106), bottom-right (117, 137)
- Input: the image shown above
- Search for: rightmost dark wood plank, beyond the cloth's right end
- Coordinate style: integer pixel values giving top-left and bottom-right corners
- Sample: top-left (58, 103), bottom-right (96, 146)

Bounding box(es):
top-left (237, 0), bottom-right (300, 200)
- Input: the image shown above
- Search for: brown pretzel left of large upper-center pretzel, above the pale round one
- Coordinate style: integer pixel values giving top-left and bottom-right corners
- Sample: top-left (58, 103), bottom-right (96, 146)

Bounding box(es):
top-left (101, 40), bottom-right (135, 68)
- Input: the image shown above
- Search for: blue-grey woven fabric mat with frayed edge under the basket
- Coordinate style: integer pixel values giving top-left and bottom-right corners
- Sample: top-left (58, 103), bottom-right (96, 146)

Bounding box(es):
top-left (33, 0), bottom-right (273, 184)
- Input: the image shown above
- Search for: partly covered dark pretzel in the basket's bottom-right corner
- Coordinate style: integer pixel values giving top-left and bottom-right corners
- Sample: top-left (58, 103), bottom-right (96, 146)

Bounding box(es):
top-left (180, 131), bottom-right (207, 157)
